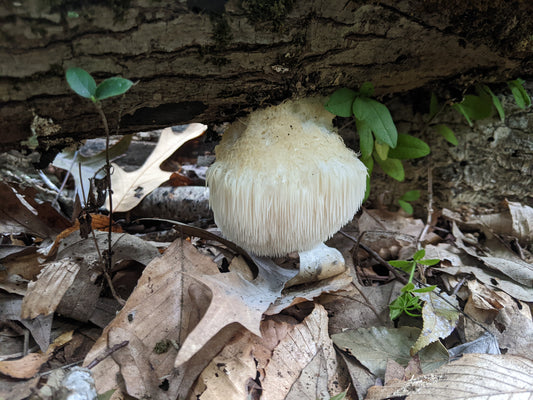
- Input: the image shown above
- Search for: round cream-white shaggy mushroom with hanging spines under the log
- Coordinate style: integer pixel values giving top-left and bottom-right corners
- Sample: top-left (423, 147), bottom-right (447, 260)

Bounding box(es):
top-left (207, 99), bottom-right (367, 256)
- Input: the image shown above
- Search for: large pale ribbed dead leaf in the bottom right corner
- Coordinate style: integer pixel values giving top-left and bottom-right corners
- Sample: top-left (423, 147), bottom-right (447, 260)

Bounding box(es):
top-left (365, 354), bottom-right (533, 400)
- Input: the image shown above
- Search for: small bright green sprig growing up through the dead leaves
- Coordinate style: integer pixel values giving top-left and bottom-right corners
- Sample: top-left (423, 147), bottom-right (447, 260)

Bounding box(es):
top-left (389, 249), bottom-right (440, 320)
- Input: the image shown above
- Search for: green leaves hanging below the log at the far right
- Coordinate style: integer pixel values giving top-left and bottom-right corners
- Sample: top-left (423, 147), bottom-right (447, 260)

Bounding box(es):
top-left (429, 79), bottom-right (531, 146)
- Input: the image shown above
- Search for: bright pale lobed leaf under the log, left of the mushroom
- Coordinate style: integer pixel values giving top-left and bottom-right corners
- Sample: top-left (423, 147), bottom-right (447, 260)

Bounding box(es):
top-left (107, 123), bottom-right (207, 212)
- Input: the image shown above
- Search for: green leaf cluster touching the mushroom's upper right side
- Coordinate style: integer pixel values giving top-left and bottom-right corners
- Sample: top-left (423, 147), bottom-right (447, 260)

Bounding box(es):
top-left (325, 82), bottom-right (430, 205)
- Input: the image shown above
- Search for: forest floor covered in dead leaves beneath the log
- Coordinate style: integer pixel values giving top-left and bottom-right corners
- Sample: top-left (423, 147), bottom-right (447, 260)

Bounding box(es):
top-left (0, 126), bottom-right (533, 400)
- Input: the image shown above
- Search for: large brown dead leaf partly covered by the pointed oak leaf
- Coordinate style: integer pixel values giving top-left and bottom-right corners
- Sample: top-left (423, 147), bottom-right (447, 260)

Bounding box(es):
top-left (84, 240), bottom-right (224, 400)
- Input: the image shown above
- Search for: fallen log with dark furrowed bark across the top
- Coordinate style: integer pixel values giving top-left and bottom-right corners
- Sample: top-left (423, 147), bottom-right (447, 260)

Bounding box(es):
top-left (0, 0), bottom-right (533, 152)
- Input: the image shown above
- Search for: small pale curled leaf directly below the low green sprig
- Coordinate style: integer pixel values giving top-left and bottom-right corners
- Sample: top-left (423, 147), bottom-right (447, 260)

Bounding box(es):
top-left (411, 292), bottom-right (459, 355)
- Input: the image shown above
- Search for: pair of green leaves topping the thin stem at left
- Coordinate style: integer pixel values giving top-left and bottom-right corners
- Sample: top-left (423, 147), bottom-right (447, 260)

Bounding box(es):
top-left (66, 68), bottom-right (133, 103)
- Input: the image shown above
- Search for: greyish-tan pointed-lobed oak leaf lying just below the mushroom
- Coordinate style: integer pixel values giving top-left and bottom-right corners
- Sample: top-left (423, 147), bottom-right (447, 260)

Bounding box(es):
top-left (174, 257), bottom-right (297, 368)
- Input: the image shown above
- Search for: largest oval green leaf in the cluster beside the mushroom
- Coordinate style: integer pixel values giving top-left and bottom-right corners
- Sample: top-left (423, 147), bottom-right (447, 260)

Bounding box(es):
top-left (353, 97), bottom-right (398, 147)
